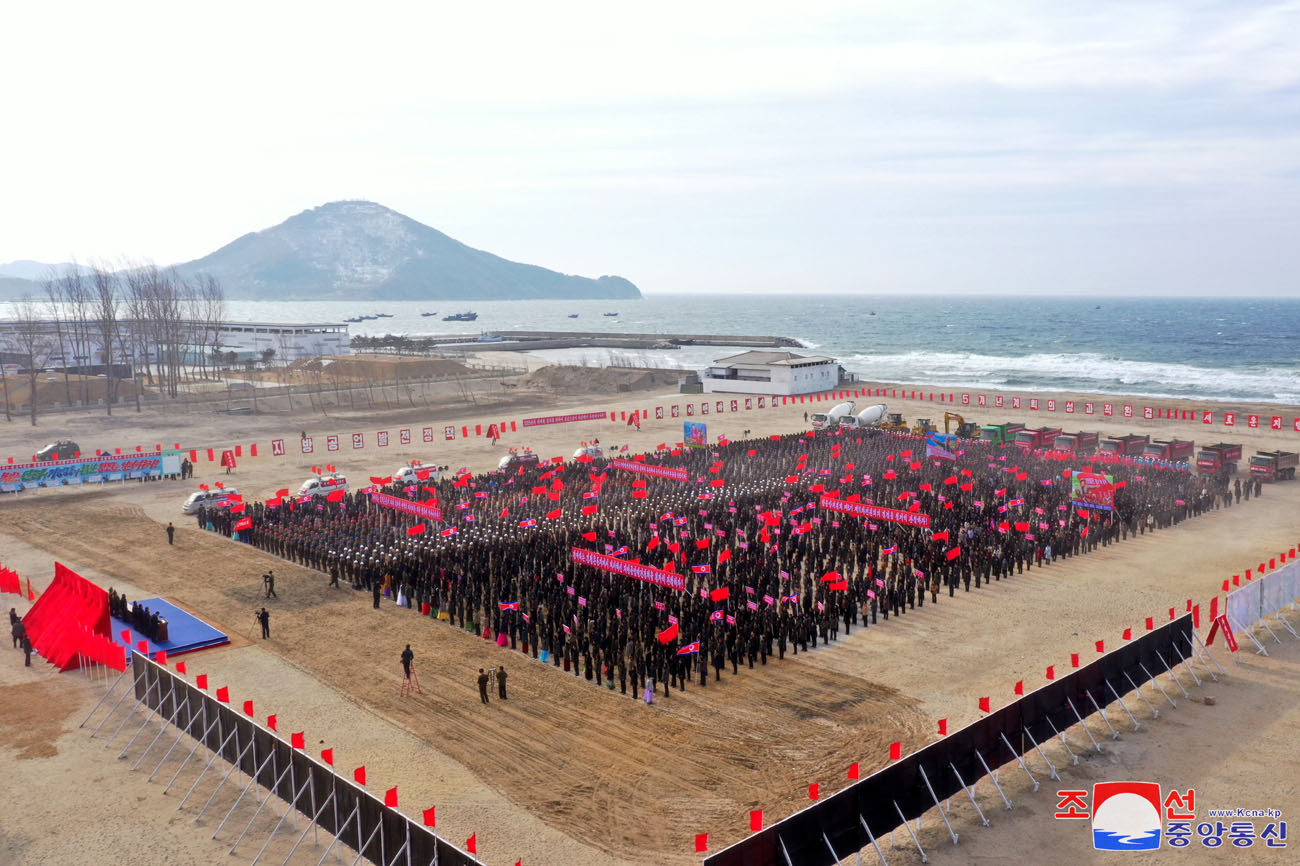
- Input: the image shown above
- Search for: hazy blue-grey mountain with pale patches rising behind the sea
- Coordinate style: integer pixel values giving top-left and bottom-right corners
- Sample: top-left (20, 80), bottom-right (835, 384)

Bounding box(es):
top-left (177, 202), bottom-right (641, 300)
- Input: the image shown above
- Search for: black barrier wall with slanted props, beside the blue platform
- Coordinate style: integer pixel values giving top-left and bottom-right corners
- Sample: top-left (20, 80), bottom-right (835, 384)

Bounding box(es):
top-left (131, 653), bottom-right (482, 866)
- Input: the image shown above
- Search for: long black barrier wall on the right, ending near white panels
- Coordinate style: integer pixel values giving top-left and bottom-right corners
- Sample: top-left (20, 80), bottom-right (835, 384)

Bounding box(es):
top-left (705, 615), bottom-right (1192, 866)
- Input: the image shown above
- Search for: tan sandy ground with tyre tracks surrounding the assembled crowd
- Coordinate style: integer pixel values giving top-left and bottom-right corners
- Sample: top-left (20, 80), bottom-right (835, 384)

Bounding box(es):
top-left (0, 371), bottom-right (1300, 866)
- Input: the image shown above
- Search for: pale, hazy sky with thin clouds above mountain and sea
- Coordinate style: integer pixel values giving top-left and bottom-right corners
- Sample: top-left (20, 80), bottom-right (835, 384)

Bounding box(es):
top-left (0, 0), bottom-right (1300, 296)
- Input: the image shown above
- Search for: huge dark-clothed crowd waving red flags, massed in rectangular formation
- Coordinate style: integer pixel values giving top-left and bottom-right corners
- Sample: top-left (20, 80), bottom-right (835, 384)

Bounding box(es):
top-left (199, 430), bottom-right (1249, 697)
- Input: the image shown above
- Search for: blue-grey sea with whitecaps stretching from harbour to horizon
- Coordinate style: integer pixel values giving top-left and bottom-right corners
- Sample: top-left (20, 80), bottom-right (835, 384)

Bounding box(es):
top-left (10, 294), bottom-right (1300, 404)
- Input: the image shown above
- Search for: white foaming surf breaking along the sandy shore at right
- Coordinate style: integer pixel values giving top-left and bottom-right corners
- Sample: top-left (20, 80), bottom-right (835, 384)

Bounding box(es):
top-left (840, 351), bottom-right (1300, 403)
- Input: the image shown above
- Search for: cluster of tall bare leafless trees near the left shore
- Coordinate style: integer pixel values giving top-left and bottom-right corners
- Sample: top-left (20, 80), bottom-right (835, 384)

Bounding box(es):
top-left (3, 263), bottom-right (225, 424)
